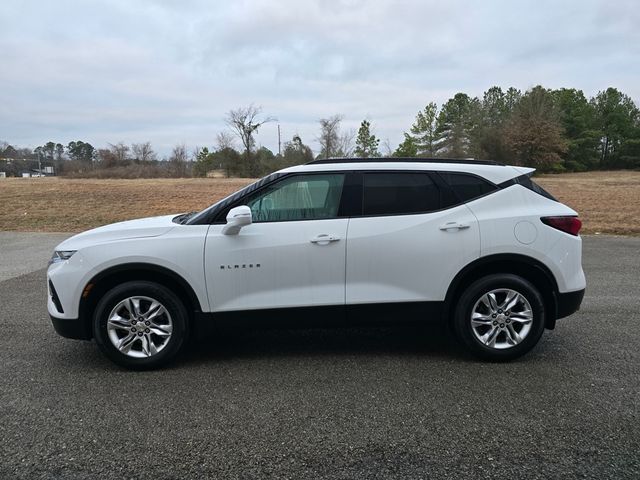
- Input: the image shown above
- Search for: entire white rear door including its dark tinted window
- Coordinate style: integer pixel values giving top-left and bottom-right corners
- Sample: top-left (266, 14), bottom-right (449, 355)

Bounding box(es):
top-left (346, 171), bottom-right (480, 304)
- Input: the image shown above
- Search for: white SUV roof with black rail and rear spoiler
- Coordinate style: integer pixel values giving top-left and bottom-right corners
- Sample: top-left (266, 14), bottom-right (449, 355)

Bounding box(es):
top-left (280, 158), bottom-right (535, 184)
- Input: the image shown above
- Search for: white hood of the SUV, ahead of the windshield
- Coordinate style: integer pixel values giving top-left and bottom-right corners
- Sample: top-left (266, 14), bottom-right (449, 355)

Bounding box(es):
top-left (56, 215), bottom-right (176, 250)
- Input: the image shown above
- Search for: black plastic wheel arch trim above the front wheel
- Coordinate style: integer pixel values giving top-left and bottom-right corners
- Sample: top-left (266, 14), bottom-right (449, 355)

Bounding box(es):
top-left (79, 263), bottom-right (202, 335)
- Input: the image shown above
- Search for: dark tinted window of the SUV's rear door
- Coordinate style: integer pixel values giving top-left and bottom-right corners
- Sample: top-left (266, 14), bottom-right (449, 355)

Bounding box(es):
top-left (363, 172), bottom-right (441, 215)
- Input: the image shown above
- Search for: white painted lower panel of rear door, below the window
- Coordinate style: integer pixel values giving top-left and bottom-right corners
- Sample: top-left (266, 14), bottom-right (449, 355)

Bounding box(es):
top-left (347, 205), bottom-right (480, 304)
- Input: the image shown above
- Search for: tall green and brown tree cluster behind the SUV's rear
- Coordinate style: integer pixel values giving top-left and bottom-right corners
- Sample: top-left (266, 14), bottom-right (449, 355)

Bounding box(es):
top-left (394, 86), bottom-right (640, 172)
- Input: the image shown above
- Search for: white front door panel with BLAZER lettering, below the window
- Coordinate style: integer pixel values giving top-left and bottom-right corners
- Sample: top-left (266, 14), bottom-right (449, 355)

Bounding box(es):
top-left (205, 218), bottom-right (349, 312)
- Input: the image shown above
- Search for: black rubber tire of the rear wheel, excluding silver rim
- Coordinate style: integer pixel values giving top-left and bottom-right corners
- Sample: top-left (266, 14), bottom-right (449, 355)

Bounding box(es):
top-left (453, 274), bottom-right (545, 361)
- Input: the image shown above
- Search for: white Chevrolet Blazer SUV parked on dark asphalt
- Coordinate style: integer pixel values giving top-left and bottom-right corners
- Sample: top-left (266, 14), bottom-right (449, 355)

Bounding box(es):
top-left (47, 159), bottom-right (585, 369)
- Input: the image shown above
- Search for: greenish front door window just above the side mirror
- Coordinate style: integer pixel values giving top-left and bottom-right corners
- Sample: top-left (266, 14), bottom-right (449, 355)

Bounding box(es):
top-left (245, 173), bottom-right (344, 223)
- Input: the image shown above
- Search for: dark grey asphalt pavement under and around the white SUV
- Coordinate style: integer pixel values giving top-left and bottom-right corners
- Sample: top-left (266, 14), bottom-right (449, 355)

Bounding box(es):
top-left (0, 236), bottom-right (640, 480)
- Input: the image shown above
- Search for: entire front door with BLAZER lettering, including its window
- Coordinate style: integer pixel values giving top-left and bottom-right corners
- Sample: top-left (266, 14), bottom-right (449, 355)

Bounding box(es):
top-left (205, 173), bottom-right (349, 312)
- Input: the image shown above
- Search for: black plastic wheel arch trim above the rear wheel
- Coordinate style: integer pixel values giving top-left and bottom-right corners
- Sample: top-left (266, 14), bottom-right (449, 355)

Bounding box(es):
top-left (443, 253), bottom-right (558, 330)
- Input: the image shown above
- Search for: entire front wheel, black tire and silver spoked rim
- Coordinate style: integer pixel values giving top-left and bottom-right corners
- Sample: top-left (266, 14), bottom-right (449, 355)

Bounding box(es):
top-left (93, 281), bottom-right (188, 370)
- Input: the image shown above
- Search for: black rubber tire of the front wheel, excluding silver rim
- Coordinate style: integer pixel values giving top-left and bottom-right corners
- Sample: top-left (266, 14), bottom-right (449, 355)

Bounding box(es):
top-left (93, 281), bottom-right (189, 370)
